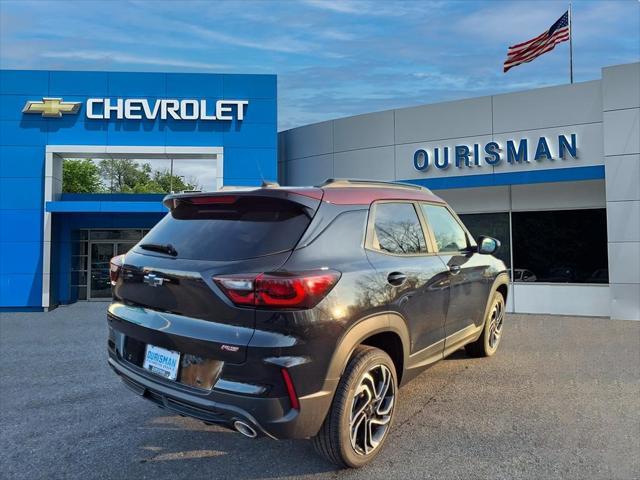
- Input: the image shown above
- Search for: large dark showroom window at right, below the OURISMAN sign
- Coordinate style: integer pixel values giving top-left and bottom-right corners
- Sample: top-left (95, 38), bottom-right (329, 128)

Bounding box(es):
top-left (512, 209), bottom-right (609, 283)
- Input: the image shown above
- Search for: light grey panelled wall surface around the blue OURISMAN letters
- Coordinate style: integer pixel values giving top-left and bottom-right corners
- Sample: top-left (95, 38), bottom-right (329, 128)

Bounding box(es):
top-left (278, 81), bottom-right (604, 185)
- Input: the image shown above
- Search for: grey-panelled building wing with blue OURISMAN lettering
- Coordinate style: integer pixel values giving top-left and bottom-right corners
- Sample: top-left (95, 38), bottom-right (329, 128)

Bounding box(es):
top-left (278, 63), bottom-right (640, 320)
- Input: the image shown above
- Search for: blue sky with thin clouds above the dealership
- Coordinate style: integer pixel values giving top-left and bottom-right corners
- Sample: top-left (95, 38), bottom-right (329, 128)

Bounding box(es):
top-left (0, 0), bottom-right (640, 129)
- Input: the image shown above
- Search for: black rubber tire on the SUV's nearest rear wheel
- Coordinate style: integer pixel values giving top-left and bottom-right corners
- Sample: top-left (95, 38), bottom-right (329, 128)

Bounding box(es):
top-left (312, 346), bottom-right (398, 468)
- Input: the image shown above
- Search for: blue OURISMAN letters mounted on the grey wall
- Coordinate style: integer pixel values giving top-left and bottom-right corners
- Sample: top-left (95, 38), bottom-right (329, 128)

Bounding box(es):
top-left (413, 133), bottom-right (578, 172)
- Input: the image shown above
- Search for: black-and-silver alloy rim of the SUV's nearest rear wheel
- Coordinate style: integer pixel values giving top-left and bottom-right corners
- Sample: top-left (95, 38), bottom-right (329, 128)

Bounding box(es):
top-left (349, 365), bottom-right (395, 455)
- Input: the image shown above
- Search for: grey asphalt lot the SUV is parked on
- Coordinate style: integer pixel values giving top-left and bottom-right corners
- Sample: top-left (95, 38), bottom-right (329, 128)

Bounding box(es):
top-left (0, 303), bottom-right (640, 480)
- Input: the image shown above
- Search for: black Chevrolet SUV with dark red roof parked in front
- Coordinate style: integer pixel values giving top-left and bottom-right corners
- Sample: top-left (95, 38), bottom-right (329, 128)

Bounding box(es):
top-left (107, 180), bottom-right (508, 467)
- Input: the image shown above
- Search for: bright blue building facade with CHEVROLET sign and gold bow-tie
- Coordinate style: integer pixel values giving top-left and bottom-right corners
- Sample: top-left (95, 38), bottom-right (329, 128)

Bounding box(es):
top-left (0, 70), bottom-right (277, 311)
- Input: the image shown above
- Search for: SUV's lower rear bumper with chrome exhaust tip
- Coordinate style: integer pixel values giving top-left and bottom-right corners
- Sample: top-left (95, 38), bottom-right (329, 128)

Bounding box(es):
top-left (108, 308), bottom-right (333, 439)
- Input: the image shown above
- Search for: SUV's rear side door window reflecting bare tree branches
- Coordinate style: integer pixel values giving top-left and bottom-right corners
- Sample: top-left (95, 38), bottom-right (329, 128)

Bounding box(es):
top-left (373, 203), bottom-right (427, 254)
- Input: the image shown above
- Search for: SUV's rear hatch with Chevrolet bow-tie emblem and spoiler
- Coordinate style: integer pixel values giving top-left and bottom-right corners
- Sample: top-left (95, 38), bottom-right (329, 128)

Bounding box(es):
top-left (110, 189), bottom-right (322, 362)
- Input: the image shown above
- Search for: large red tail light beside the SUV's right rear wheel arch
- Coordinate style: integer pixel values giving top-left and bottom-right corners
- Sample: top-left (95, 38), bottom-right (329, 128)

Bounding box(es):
top-left (213, 270), bottom-right (340, 308)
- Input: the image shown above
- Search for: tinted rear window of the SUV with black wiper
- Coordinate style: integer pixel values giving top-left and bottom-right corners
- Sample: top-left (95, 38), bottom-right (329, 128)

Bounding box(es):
top-left (136, 196), bottom-right (311, 260)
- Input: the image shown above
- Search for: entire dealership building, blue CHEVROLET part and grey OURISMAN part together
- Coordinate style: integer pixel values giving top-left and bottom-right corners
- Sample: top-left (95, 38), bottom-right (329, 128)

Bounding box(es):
top-left (0, 63), bottom-right (640, 320)
